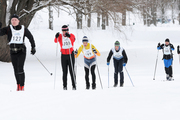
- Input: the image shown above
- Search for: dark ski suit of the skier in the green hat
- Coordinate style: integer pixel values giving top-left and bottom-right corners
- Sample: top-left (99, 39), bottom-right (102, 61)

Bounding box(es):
top-left (107, 48), bottom-right (128, 85)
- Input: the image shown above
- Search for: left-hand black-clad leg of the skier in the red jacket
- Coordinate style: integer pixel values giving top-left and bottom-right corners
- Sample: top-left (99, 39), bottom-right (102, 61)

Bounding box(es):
top-left (61, 55), bottom-right (68, 88)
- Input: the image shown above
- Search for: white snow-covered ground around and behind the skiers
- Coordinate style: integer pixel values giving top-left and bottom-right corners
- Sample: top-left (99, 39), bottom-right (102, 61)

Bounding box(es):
top-left (0, 9), bottom-right (180, 120)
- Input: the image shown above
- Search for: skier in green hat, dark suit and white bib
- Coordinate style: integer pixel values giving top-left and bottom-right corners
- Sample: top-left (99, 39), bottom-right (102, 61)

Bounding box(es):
top-left (107, 41), bottom-right (128, 87)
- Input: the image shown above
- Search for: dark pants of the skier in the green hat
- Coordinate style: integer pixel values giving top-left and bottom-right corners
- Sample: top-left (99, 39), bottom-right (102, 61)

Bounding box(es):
top-left (113, 59), bottom-right (124, 84)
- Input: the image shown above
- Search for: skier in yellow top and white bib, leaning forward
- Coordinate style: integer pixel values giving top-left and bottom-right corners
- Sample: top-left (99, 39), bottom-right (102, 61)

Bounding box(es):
top-left (75, 36), bottom-right (100, 90)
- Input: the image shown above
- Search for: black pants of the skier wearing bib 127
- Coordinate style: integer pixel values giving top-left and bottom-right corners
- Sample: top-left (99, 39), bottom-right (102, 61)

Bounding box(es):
top-left (11, 50), bottom-right (26, 86)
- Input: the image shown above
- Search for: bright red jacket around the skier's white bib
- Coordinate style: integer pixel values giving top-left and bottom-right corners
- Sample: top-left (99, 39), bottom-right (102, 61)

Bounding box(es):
top-left (54, 34), bottom-right (76, 55)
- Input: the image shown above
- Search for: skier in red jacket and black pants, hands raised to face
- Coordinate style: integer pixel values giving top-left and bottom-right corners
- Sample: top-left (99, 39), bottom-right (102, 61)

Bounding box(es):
top-left (54, 25), bottom-right (76, 90)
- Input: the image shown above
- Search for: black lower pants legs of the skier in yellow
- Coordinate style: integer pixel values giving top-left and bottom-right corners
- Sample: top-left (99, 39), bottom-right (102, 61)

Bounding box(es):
top-left (84, 65), bottom-right (96, 87)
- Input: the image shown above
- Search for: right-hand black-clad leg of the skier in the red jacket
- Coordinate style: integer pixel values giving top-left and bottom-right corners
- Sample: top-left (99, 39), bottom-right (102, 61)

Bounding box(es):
top-left (68, 52), bottom-right (76, 88)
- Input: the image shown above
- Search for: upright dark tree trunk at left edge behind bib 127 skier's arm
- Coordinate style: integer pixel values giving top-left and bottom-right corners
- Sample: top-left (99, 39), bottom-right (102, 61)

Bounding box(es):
top-left (0, 0), bottom-right (11, 62)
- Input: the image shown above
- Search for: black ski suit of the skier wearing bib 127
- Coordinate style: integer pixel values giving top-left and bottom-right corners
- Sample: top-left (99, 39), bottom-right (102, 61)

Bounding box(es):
top-left (0, 25), bottom-right (35, 86)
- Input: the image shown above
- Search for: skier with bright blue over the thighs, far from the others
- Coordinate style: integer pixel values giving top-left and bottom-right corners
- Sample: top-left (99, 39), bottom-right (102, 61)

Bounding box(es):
top-left (157, 39), bottom-right (174, 81)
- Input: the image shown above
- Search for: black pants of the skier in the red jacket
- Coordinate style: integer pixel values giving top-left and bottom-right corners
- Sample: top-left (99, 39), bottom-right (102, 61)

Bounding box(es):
top-left (61, 51), bottom-right (76, 87)
